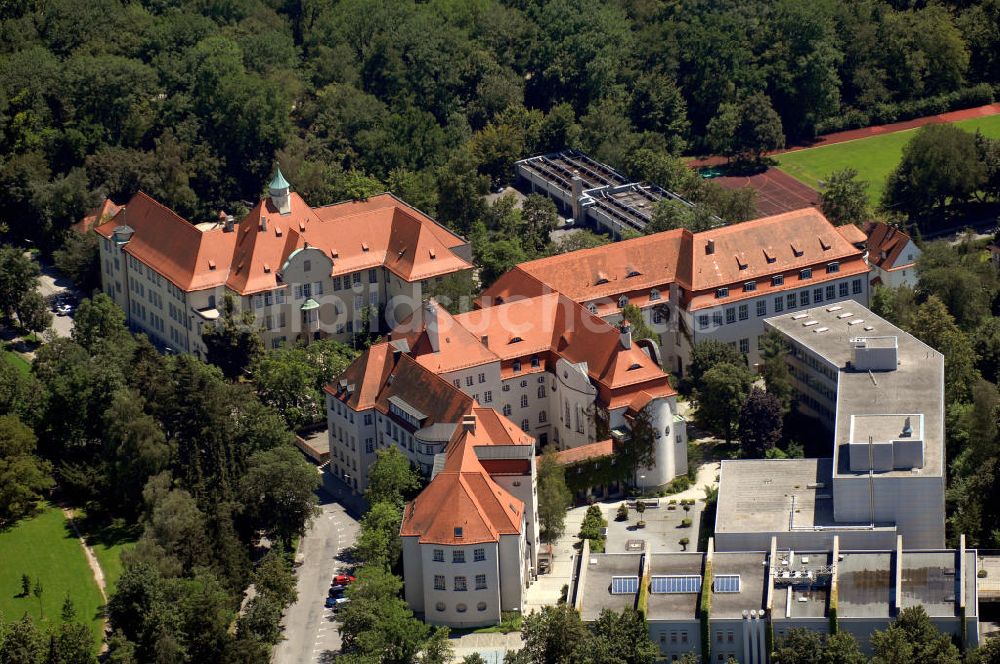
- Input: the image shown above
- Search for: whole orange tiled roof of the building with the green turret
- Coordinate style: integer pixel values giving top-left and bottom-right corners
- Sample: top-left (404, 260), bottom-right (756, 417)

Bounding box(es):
top-left (98, 192), bottom-right (472, 295)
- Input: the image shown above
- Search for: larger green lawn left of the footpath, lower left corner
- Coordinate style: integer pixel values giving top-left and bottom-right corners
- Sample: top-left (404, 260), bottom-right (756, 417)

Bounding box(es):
top-left (0, 506), bottom-right (102, 646)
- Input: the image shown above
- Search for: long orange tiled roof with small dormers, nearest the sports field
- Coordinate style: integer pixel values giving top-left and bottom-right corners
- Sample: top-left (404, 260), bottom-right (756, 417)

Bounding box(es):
top-left (480, 208), bottom-right (867, 315)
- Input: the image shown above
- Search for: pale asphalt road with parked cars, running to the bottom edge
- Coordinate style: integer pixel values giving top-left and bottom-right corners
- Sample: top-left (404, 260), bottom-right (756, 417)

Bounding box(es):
top-left (271, 482), bottom-right (358, 664)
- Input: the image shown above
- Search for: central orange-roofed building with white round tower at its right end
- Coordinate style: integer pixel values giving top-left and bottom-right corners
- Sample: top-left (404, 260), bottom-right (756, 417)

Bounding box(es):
top-left (327, 293), bottom-right (687, 491)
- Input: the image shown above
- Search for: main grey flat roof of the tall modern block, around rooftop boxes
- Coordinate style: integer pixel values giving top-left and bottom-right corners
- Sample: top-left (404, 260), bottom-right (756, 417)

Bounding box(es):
top-left (765, 300), bottom-right (944, 477)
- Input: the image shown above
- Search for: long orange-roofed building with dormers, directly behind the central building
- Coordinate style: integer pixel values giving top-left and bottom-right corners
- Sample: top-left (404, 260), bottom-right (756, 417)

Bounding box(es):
top-left (478, 208), bottom-right (869, 375)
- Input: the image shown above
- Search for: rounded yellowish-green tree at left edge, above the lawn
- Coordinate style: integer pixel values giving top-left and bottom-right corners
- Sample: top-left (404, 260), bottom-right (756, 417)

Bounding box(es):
top-left (0, 415), bottom-right (53, 527)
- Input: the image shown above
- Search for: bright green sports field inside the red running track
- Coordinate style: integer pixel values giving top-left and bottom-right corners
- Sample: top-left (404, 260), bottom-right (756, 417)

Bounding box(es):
top-left (776, 115), bottom-right (1000, 204)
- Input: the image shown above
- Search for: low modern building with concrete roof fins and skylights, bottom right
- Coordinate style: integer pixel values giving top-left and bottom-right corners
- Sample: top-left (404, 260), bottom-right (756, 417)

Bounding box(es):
top-left (571, 537), bottom-right (979, 664)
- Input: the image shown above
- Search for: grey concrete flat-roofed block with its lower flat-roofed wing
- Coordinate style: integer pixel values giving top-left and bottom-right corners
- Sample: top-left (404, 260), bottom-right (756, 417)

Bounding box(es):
top-left (716, 302), bottom-right (945, 551)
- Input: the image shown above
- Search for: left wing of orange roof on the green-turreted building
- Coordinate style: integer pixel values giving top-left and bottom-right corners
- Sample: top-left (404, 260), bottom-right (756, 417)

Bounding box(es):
top-left (95, 191), bottom-right (236, 292)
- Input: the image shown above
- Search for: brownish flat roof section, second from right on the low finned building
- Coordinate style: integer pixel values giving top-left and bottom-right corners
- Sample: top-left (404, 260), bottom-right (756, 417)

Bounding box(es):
top-left (837, 551), bottom-right (894, 618)
